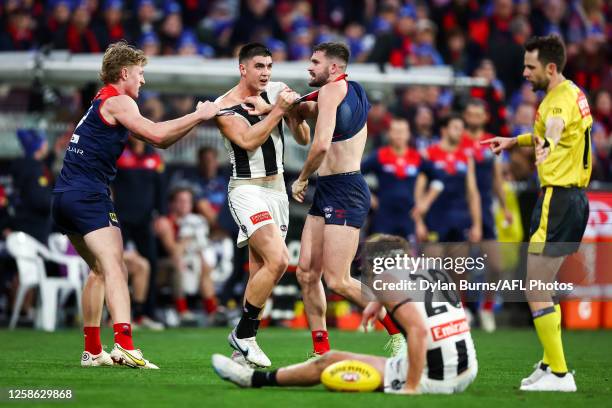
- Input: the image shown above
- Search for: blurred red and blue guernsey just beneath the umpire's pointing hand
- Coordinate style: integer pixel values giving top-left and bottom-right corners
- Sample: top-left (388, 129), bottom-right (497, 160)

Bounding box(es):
top-left (460, 133), bottom-right (497, 240)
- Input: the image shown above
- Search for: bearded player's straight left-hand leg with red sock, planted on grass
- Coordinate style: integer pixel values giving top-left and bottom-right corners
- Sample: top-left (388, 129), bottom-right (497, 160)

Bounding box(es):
top-left (297, 215), bottom-right (330, 354)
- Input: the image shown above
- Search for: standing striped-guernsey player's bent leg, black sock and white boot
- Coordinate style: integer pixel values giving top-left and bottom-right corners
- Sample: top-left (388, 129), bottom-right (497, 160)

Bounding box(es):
top-left (228, 224), bottom-right (289, 367)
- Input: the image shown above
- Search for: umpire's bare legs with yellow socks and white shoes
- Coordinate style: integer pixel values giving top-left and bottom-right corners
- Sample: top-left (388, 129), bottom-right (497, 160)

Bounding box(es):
top-left (520, 254), bottom-right (576, 392)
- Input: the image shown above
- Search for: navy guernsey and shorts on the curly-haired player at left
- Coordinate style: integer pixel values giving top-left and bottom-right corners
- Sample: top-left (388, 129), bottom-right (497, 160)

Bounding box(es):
top-left (51, 85), bottom-right (128, 235)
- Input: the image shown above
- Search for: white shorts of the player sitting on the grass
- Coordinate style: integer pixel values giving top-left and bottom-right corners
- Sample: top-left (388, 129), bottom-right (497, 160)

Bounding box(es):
top-left (384, 356), bottom-right (478, 394)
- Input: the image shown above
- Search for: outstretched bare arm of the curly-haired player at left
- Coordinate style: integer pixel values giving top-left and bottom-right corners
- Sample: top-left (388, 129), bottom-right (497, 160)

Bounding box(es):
top-left (102, 95), bottom-right (219, 149)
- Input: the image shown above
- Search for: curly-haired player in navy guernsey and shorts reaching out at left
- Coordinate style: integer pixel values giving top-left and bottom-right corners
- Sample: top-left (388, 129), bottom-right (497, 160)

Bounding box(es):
top-left (52, 41), bottom-right (218, 368)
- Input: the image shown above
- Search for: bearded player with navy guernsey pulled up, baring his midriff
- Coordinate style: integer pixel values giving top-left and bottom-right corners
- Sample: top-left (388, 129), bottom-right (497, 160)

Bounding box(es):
top-left (291, 43), bottom-right (406, 355)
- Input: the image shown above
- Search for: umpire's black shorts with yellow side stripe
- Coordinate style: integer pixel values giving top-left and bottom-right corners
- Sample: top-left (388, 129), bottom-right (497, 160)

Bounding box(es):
top-left (529, 187), bottom-right (589, 257)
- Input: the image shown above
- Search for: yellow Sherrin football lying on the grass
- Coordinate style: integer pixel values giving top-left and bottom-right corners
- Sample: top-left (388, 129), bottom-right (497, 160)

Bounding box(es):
top-left (321, 360), bottom-right (382, 392)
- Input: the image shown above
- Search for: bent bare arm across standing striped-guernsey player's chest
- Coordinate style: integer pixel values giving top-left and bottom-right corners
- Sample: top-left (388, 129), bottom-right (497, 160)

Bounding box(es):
top-left (216, 89), bottom-right (298, 151)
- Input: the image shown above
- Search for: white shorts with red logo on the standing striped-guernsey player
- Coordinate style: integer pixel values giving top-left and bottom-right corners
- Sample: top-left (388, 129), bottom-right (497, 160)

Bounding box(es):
top-left (228, 185), bottom-right (289, 248)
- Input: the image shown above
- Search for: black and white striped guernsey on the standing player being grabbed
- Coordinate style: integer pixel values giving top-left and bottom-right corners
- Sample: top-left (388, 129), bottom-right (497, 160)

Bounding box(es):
top-left (215, 82), bottom-right (285, 179)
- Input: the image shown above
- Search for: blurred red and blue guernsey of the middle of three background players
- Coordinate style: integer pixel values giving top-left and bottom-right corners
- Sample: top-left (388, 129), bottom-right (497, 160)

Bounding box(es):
top-left (426, 143), bottom-right (472, 242)
